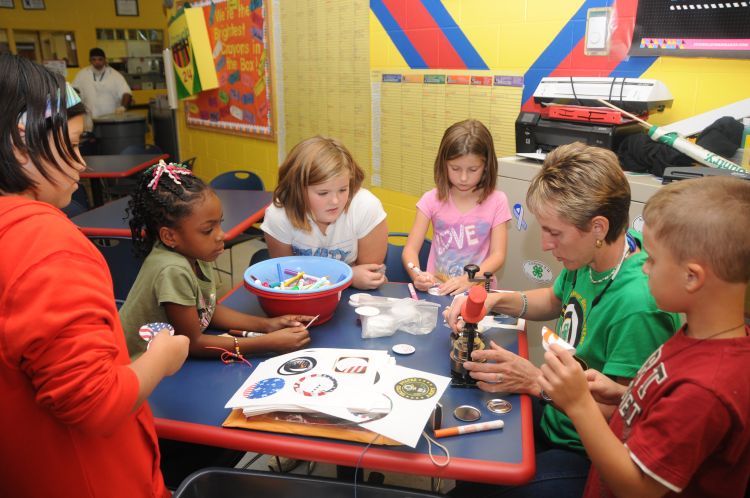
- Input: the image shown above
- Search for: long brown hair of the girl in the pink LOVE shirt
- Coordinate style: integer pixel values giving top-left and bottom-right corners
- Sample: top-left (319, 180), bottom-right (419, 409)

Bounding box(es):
top-left (434, 119), bottom-right (497, 203)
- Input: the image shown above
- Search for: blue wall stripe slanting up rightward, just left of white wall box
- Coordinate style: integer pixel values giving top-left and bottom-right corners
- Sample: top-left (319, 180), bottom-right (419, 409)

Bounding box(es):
top-left (521, 0), bottom-right (612, 105)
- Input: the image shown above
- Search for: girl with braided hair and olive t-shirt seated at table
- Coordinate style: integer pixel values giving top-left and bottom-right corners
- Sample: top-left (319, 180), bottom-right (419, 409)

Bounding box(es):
top-left (120, 161), bottom-right (312, 359)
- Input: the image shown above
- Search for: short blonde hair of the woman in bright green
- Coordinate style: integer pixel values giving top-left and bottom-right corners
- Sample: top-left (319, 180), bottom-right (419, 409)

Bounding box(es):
top-left (526, 142), bottom-right (630, 244)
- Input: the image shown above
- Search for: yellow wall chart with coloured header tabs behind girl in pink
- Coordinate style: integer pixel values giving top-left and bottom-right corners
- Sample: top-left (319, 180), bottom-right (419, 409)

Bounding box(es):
top-left (371, 70), bottom-right (523, 197)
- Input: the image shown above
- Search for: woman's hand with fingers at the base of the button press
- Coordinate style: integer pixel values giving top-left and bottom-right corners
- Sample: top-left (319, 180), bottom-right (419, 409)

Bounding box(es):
top-left (464, 341), bottom-right (539, 395)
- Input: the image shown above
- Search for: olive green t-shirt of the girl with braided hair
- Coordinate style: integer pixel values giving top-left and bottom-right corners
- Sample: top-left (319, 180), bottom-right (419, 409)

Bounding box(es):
top-left (120, 242), bottom-right (216, 360)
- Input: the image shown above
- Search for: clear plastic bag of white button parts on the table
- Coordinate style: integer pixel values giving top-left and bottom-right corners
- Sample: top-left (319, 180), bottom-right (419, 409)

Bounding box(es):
top-left (355, 296), bottom-right (440, 339)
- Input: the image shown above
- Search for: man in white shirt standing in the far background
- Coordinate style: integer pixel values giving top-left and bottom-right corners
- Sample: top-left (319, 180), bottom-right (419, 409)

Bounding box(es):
top-left (72, 48), bottom-right (133, 131)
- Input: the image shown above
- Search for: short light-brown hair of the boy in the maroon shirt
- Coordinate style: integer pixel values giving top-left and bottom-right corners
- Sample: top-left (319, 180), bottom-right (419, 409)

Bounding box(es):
top-left (643, 177), bottom-right (750, 283)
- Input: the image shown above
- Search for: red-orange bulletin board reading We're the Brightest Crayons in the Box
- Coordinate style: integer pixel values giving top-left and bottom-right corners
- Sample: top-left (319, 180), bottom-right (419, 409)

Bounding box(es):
top-left (185, 0), bottom-right (275, 140)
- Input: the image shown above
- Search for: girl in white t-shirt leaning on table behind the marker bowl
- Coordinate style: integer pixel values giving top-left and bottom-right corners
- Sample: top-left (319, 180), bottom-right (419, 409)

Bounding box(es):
top-left (261, 136), bottom-right (388, 289)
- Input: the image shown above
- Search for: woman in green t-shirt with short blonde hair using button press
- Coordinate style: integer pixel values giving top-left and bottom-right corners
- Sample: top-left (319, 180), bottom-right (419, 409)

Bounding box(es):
top-left (446, 143), bottom-right (679, 498)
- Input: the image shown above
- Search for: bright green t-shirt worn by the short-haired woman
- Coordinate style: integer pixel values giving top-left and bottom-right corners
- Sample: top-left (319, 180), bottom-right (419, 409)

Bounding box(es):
top-left (541, 231), bottom-right (680, 451)
